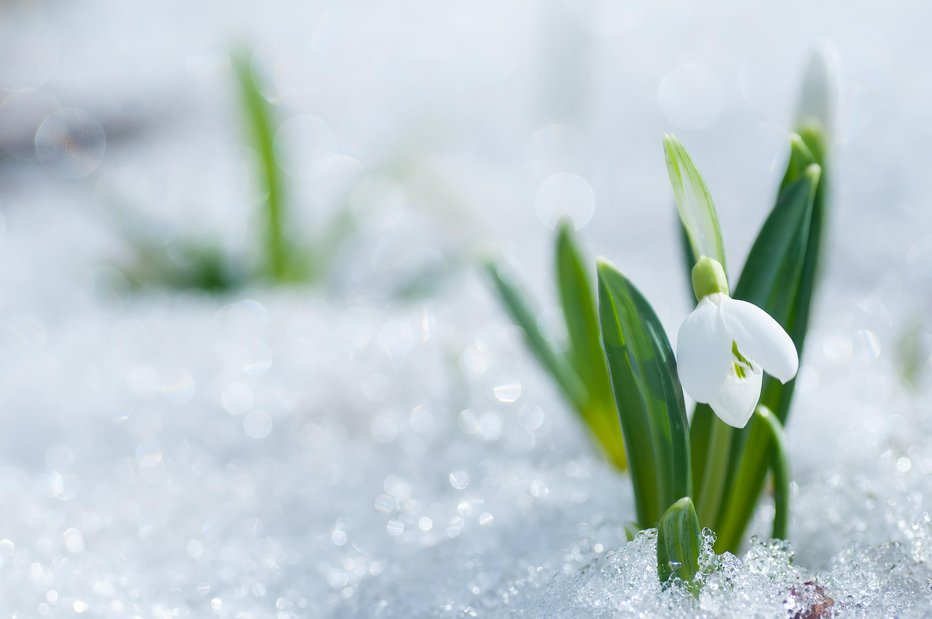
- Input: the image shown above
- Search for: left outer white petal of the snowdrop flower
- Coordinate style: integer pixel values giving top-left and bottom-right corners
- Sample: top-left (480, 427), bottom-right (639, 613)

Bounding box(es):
top-left (676, 297), bottom-right (732, 402)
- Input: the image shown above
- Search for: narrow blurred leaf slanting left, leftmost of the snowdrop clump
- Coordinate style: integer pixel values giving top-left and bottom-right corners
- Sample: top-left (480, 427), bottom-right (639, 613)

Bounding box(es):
top-left (486, 262), bottom-right (586, 410)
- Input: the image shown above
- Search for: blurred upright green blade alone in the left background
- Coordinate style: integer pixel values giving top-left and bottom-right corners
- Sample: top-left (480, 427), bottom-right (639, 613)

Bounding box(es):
top-left (232, 50), bottom-right (290, 282)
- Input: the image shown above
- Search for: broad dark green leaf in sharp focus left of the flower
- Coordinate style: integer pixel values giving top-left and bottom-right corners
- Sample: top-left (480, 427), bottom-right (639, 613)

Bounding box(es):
top-left (598, 262), bottom-right (692, 528)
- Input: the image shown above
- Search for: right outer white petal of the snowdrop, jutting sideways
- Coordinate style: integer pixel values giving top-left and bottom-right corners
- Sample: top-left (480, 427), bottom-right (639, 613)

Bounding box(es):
top-left (722, 298), bottom-right (799, 383)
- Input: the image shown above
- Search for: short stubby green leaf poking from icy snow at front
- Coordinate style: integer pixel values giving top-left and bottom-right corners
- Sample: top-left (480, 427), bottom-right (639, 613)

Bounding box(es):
top-left (657, 497), bottom-right (702, 595)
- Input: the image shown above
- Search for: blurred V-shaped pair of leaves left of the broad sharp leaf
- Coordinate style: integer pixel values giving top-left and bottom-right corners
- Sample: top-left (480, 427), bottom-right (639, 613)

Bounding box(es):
top-left (487, 220), bottom-right (627, 470)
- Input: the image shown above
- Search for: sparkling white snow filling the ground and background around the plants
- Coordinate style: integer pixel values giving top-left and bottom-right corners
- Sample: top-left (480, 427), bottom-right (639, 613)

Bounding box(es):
top-left (0, 1), bottom-right (932, 618)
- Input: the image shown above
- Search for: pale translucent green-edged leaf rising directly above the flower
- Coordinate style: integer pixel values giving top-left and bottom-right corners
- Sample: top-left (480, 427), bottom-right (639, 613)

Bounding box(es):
top-left (663, 135), bottom-right (728, 273)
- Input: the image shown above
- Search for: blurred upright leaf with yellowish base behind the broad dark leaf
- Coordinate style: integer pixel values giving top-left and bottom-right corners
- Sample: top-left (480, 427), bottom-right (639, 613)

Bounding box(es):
top-left (556, 220), bottom-right (627, 470)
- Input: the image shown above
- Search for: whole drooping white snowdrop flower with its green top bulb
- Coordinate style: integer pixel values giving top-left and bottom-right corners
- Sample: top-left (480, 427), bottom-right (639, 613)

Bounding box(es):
top-left (676, 257), bottom-right (799, 428)
